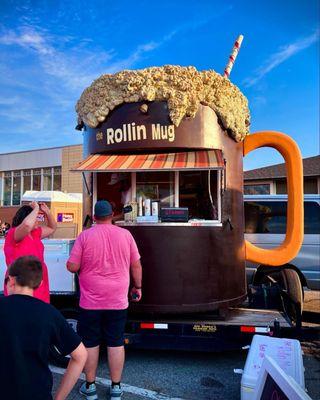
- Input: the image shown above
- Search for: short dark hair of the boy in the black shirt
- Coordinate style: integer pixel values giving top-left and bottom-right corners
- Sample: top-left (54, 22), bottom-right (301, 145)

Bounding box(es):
top-left (8, 256), bottom-right (42, 289)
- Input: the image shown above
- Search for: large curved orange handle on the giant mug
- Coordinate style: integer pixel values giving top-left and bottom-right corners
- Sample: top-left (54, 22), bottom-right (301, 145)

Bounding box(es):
top-left (243, 131), bottom-right (304, 266)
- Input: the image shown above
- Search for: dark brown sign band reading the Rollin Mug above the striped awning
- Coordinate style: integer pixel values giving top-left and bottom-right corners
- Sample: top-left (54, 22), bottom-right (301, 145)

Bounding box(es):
top-left (85, 102), bottom-right (215, 154)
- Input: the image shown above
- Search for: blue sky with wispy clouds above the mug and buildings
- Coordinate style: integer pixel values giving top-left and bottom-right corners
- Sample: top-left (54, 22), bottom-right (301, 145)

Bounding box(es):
top-left (0, 0), bottom-right (319, 169)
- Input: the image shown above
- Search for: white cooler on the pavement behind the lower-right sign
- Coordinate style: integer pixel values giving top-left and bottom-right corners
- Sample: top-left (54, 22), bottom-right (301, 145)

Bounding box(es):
top-left (241, 335), bottom-right (305, 400)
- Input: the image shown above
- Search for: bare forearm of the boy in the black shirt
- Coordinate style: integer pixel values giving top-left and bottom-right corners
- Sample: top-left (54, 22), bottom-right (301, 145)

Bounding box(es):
top-left (55, 343), bottom-right (87, 400)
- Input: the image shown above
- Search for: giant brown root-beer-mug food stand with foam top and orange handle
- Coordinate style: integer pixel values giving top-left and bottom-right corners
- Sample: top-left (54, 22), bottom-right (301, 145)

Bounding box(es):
top-left (75, 66), bottom-right (303, 313)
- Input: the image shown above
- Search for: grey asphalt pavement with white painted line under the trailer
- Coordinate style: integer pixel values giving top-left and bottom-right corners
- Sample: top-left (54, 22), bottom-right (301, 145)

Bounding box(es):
top-left (53, 342), bottom-right (320, 400)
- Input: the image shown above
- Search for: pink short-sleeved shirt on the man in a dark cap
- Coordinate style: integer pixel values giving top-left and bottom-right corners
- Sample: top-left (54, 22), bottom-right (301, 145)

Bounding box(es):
top-left (69, 224), bottom-right (140, 310)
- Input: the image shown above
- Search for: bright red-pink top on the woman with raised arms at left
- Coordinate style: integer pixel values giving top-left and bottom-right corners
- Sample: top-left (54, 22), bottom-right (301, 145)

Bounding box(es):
top-left (3, 227), bottom-right (50, 303)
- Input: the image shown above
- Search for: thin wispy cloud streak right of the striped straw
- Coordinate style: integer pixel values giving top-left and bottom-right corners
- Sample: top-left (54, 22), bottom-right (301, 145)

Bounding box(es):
top-left (244, 30), bottom-right (319, 87)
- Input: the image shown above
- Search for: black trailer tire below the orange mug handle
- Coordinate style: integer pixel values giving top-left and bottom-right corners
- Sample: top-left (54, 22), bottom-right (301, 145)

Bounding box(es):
top-left (281, 269), bottom-right (303, 323)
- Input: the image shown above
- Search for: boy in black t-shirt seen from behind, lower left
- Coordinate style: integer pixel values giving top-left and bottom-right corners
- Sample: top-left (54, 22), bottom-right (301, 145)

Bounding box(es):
top-left (0, 256), bottom-right (87, 400)
